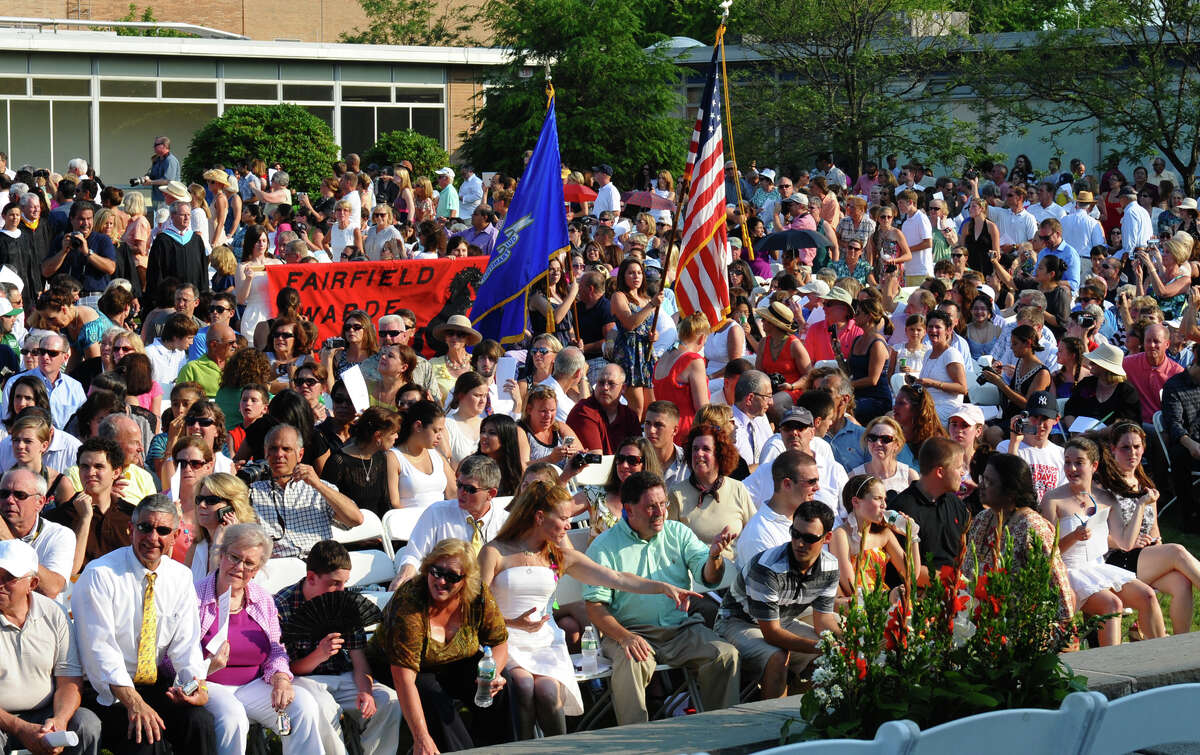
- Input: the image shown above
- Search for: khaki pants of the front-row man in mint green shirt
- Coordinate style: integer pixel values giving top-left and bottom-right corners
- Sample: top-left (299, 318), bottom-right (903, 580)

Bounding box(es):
top-left (601, 621), bottom-right (739, 725)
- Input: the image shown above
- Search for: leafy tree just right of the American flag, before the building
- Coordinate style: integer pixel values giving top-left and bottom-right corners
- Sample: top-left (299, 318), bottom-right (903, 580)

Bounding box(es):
top-left (731, 0), bottom-right (985, 175)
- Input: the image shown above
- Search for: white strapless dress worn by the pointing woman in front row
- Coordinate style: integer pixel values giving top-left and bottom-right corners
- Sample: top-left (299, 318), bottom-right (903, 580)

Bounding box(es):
top-left (492, 567), bottom-right (583, 715)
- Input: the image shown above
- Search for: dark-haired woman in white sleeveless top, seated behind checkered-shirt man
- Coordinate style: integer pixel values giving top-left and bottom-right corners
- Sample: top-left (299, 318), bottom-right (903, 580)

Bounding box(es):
top-left (391, 401), bottom-right (457, 509)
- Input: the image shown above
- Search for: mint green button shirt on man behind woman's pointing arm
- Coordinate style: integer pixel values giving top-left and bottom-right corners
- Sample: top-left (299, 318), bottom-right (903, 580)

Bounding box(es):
top-left (583, 519), bottom-right (715, 627)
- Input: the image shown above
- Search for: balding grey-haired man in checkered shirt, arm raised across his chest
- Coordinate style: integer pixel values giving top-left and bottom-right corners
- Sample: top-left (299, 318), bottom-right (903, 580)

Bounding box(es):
top-left (250, 424), bottom-right (362, 558)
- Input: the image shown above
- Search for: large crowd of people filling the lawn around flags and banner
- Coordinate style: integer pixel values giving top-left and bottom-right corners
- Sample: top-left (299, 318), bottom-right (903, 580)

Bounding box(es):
top-left (0, 142), bottom-right (1200, 755)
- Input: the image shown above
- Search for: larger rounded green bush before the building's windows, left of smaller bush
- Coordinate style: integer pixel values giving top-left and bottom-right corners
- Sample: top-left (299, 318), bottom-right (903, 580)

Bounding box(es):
top-left (182, 104), bottom-right (338, 192)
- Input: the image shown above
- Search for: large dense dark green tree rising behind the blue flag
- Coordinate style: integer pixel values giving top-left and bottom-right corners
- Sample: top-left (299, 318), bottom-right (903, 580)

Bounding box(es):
top-left (462, 0), bottom-right (686, 185)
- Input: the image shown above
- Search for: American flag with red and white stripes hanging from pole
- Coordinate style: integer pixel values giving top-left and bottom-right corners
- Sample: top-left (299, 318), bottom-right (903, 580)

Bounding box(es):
top-left (674, 47), bottom-right (730, 328)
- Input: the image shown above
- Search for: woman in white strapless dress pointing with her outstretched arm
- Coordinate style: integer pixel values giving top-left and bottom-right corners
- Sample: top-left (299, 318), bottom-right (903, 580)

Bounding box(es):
top-left (479, 481), bottom-right (701, 739)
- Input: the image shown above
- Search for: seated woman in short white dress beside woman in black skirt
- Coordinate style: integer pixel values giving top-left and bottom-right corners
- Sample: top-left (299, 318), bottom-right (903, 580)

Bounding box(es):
top-left (1039, 436), bottom-right (1166, 647)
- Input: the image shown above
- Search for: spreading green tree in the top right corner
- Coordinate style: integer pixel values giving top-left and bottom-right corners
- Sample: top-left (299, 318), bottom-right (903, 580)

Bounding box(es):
top-left (967, 0), bottom-right (1200, 193)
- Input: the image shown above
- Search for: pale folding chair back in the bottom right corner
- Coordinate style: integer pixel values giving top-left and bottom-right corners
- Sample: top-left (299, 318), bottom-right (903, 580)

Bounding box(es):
top-left (1084, 684), bottom-right (1200, 755)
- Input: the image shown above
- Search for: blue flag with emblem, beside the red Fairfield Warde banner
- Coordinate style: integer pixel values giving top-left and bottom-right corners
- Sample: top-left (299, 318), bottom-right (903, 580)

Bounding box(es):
top-left (470, 97), bottom-right (570, 343)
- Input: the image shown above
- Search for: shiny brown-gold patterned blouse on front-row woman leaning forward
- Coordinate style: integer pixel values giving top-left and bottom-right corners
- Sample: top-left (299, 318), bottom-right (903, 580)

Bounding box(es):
top-left (367, 575), bottom-right (509, 672)
